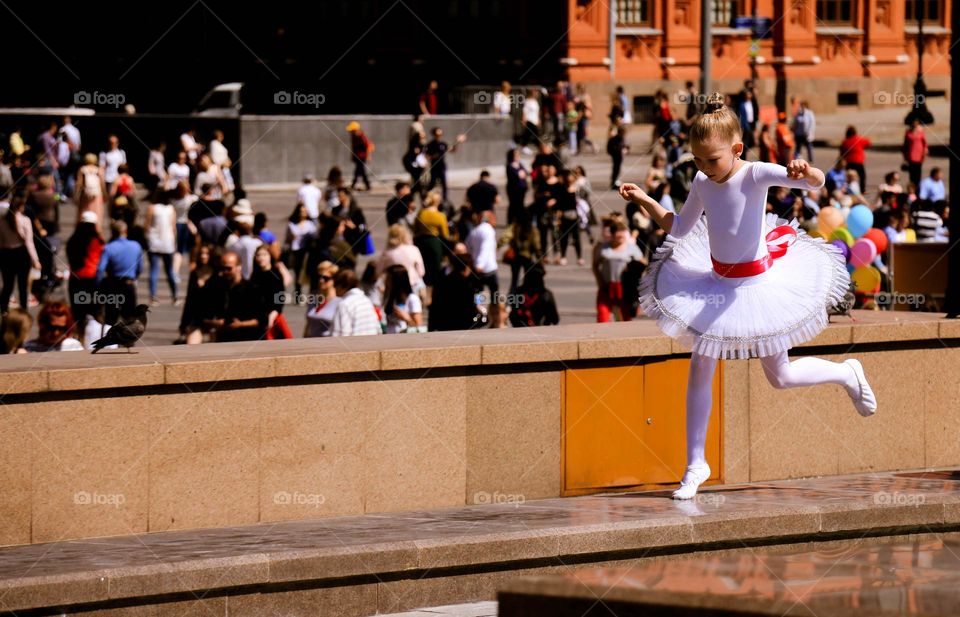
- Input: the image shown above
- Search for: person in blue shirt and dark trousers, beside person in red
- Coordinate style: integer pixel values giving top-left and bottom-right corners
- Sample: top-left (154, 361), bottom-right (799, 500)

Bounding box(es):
top-left (97, 221), bottom-right (143, 325)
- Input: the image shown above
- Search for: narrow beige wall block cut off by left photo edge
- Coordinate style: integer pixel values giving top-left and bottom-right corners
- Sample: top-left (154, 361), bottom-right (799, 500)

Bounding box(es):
top-left (0, 405), bottom-right (34, 546)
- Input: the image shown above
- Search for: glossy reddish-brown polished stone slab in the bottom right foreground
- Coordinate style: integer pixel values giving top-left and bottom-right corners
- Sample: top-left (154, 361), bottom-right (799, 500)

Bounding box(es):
top-left (499, 533), bottom-right (960, 617)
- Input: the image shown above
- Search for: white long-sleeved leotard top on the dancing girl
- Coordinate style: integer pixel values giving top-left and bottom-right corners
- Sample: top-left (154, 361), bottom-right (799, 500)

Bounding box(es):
top-left (670, 161), bottom-right (823, 264)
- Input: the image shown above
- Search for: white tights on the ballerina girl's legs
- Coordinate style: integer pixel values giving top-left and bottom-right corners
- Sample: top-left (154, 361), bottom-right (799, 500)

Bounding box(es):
top-left (687, 351), bottom-right (857, 465)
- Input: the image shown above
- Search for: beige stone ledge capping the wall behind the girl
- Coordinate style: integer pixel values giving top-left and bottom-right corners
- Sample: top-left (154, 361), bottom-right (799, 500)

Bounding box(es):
top-left (0, 311), bottom-right (944, 399)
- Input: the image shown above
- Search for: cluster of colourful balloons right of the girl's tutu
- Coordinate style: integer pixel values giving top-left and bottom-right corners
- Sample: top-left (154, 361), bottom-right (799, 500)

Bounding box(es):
top-left (811, 204), bottom-right (887, 294)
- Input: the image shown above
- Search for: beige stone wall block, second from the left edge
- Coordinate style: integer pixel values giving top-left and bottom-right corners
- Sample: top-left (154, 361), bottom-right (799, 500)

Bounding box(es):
top-left (26, 398), bottom-right (149, 542)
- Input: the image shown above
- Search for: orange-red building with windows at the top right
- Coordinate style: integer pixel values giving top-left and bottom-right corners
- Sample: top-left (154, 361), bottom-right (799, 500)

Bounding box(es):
top-left (563, 0), bottom-right (953, 120)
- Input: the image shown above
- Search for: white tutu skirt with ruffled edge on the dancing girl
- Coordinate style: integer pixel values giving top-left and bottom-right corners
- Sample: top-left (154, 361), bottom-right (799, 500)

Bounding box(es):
top-left (640, 213), bottom-right (850, 359)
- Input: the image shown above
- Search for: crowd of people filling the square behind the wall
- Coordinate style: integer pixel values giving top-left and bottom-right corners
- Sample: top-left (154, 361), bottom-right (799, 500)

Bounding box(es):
top-left (0, 81), bottom-right (949, 352)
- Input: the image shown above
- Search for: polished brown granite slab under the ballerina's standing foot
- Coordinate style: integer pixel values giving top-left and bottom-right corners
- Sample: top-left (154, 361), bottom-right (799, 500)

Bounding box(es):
top-left (0, 470), bottom-right (960, 610)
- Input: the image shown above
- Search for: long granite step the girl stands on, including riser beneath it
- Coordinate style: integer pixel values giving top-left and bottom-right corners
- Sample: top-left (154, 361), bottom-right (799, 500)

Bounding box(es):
top-left (0, 470), bottom-right (960, 617)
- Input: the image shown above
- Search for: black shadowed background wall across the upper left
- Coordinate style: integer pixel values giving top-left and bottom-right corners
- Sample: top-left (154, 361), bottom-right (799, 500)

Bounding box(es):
top-left (0, 0), bottom-right (567, 114)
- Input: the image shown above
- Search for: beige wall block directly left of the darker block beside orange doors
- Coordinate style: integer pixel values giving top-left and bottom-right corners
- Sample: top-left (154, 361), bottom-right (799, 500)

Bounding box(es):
top-left (362, 377), bottom-right (467, 512)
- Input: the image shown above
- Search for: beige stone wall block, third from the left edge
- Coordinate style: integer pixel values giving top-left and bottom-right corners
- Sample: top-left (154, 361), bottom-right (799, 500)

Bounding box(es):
top-left (148, 389), bottom-right (258, 531)
